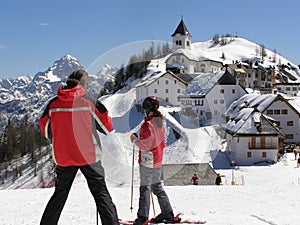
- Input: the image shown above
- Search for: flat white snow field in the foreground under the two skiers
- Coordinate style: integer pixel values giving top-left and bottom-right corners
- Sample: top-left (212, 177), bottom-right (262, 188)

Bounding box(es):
top-left (0, 153), bottom-right (300, 225)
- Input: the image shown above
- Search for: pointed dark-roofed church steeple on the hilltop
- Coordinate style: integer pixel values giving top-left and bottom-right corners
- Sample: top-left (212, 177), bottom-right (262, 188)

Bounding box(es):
top-left (171, 17), bottom-right (192, 51)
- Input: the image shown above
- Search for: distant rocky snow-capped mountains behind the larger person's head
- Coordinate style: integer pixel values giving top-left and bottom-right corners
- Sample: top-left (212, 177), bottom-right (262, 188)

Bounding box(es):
top-left (0, 55), bottom-right (116, 135)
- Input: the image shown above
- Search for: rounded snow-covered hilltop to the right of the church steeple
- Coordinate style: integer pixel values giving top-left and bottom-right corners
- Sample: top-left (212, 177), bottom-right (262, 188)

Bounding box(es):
top-left (192, 37), bottom-right (300, 83)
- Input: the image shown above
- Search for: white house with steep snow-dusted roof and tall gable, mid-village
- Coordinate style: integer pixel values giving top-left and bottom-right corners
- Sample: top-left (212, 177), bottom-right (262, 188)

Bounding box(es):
top-left (178, 71), bottom-right (247, 126)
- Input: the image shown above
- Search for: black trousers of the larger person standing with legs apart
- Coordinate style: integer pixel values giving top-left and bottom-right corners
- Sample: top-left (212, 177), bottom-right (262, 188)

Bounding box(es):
top-left (40, 161), bottom-right (119, 225)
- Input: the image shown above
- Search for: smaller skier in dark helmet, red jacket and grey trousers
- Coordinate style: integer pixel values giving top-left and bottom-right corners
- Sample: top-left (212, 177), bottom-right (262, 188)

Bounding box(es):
top-left (130, 96), bottom-right (174, 225)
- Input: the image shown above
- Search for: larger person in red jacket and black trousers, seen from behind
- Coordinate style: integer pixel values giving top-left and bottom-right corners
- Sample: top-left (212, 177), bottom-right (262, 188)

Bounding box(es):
top-left (39, 70), bottom-right (119, 225)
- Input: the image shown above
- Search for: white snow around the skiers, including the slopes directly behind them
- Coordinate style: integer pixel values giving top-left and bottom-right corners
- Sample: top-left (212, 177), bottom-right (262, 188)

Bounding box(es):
top-left (0, 91), bottom-right (300, 225)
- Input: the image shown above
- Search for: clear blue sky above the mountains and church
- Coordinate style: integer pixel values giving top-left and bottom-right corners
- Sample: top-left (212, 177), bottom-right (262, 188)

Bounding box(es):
top-left (0, 0), bottom-right (300, 79)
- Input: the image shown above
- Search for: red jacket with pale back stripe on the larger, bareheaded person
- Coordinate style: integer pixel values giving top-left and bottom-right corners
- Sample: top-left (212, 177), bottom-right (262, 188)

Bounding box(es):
top-left (39, 85), bottom-right (112, 166)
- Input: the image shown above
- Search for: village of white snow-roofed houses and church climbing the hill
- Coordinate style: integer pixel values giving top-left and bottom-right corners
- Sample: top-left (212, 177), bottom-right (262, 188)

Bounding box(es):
top-left (136, 19), bottom-right (300, 165)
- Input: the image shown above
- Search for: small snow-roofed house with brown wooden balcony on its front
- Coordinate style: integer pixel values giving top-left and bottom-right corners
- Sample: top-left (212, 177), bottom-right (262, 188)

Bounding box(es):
top-left (226, 108), bottom-right (283, 165)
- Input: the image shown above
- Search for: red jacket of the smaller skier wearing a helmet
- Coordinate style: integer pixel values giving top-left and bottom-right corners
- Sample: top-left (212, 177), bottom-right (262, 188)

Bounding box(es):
top-left (135, 117), bottom-right (166, 168)
